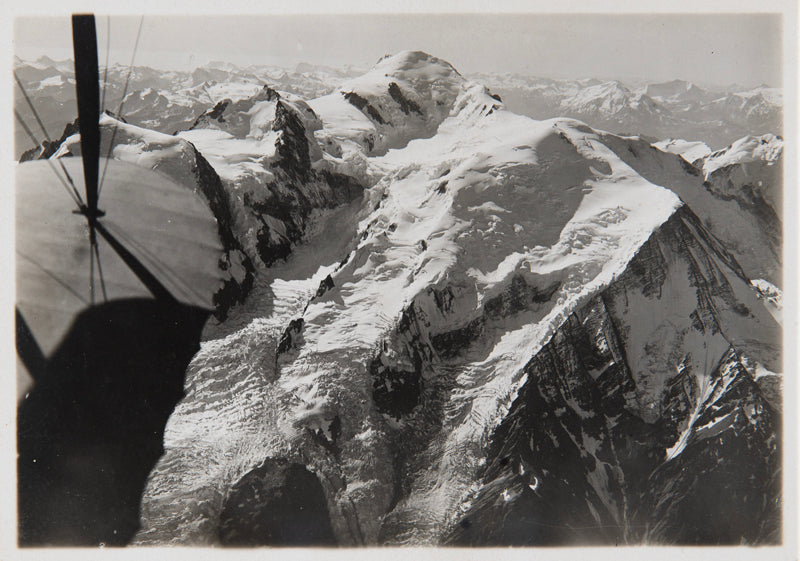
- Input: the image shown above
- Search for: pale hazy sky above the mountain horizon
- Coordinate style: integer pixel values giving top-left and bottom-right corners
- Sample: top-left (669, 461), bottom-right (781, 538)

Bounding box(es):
top-left (14, 13), bottom-right (783, 86)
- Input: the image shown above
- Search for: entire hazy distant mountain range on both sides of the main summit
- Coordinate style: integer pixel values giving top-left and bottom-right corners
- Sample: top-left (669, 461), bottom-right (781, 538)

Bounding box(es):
top-left (14, 57), bottom-right (783, 156)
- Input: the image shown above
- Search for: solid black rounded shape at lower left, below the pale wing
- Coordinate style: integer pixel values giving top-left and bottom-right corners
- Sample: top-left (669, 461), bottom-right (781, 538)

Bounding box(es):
top-left (17, 300), bottom-right (208, 546)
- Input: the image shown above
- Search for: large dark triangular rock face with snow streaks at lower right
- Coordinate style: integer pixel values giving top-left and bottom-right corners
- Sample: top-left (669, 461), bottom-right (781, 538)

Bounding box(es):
top-left (447, 210), bottom-right (781, 545)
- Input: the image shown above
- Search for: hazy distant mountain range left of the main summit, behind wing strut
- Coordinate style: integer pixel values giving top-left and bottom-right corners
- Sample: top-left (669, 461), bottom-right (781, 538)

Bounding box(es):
top-left (14, 57), bottom-right (359, 157)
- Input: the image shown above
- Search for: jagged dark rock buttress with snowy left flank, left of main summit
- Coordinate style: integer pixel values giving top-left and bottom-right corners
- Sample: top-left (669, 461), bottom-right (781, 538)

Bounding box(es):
top-left (182, 82), bottom-right (362, 267)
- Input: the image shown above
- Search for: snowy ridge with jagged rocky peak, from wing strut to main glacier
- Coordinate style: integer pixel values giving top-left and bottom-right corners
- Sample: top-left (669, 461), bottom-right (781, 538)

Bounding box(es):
top-left (53, 86), bottom-right (361, 278)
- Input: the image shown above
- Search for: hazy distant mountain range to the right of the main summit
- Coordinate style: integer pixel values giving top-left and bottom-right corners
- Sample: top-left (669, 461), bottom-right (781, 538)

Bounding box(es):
top-left (471, 74), bottom-right (783, 149)
